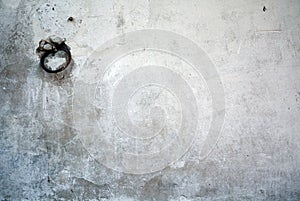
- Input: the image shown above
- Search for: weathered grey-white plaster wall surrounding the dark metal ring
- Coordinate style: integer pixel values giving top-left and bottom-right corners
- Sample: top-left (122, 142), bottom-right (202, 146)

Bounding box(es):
top-left (0, 0), bottom-right (300, 200)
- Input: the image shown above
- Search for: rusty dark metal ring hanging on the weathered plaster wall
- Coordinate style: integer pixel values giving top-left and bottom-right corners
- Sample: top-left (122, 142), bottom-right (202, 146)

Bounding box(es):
top-left (40, 42), bottom-right (72, 73)
